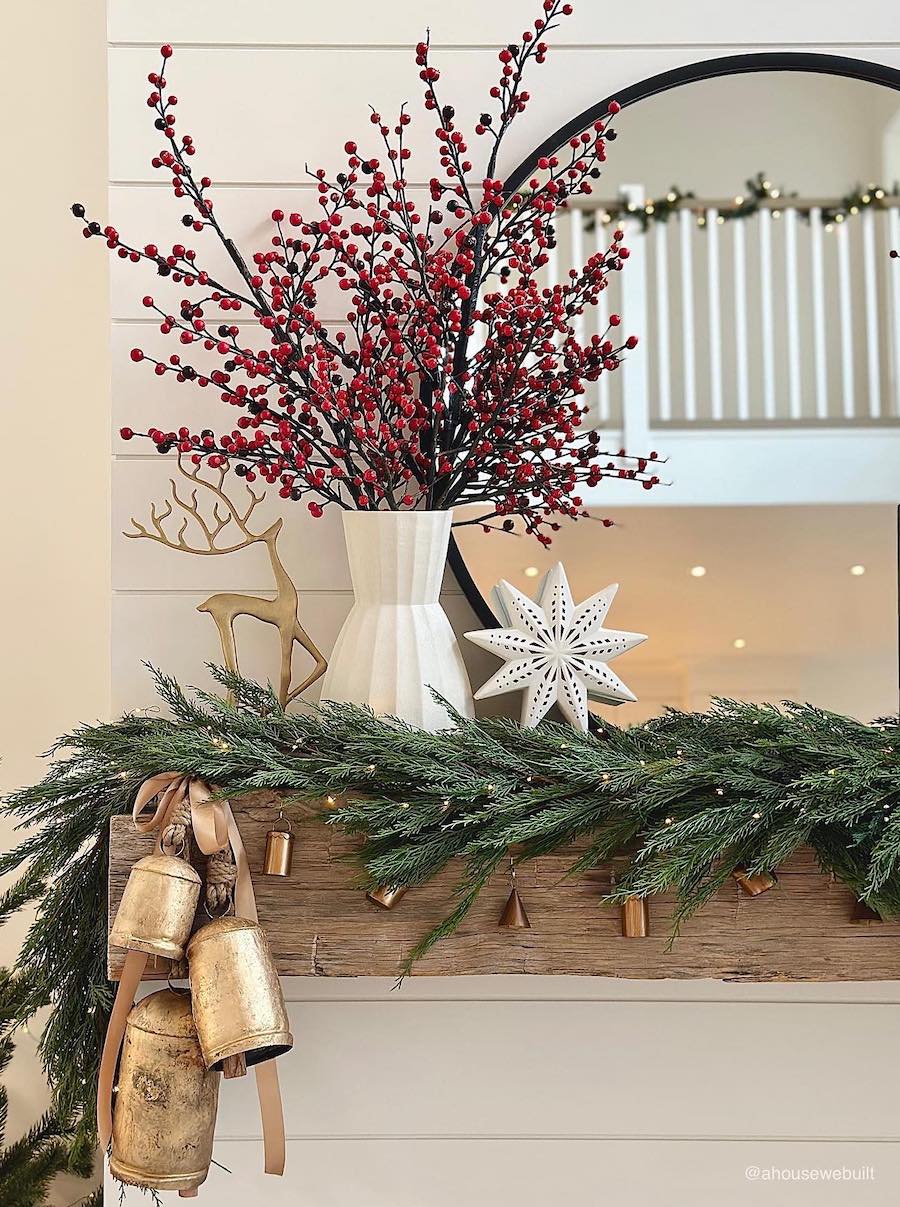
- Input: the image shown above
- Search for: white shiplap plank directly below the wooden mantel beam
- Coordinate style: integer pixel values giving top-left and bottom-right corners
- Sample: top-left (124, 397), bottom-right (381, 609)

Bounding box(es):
top-left (114, 984), bottom-right (900, 1141)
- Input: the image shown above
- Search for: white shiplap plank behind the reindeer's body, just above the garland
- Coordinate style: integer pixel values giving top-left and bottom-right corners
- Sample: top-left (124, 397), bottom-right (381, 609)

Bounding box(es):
top-left (112, 589), bottom-right (480, 712)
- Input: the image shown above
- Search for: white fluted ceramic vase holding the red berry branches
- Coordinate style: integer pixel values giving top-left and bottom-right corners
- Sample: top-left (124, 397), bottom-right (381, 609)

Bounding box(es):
top-left (322, 512), bottom-right (474, 731)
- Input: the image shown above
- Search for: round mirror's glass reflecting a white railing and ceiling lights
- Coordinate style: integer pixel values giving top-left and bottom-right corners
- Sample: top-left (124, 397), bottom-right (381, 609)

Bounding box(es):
top-left (454, 56), bottom-right (900, 723)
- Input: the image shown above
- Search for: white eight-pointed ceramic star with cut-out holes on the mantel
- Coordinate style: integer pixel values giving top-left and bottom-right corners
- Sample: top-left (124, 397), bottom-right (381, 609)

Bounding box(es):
top-left (466, 562), bottom-right (647, 731)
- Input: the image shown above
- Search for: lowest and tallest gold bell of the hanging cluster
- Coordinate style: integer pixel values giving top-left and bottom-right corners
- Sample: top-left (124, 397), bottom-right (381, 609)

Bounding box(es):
top-left (110, 989), bottom-right (218, 1197)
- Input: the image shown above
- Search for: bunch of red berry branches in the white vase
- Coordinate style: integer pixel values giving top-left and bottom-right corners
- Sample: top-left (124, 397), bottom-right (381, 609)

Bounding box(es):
top-left (72, 0), bottom-right (659, 543)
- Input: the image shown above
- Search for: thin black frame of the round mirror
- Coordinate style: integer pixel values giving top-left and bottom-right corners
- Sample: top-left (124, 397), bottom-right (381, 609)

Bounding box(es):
top-left (448, 51), bottom-right (900, 629)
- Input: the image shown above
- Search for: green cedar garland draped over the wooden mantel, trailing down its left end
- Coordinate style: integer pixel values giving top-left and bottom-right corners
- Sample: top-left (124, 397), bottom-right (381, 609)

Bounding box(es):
top-left (0, 669), bottom-right (900, 1148)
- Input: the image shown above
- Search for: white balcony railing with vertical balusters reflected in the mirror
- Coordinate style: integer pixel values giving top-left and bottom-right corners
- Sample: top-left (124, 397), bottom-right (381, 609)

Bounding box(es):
top-left (548, 185), bottom-right (900, 447)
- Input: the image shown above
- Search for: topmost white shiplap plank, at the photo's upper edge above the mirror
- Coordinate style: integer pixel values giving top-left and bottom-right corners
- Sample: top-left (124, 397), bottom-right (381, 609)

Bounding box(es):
top-left (109, 0), bottom-right (898, 48)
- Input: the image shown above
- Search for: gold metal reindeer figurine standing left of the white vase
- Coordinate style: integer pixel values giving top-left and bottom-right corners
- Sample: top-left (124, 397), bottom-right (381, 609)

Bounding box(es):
top-left (124, 457), bottom-right (328, 707)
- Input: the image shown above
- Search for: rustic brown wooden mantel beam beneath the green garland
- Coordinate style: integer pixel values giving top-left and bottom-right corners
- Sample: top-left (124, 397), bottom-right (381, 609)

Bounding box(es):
top-left (109, 793), bottom-right (900, 981)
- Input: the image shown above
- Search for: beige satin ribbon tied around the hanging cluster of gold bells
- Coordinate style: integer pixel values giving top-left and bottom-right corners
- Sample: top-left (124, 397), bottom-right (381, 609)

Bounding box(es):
top-left (97, 771), bottom-right (286, 1174)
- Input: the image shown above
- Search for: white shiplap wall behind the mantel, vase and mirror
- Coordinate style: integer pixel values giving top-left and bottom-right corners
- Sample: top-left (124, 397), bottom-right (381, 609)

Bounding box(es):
top-left (109, 0), bottom-right (900, 1207)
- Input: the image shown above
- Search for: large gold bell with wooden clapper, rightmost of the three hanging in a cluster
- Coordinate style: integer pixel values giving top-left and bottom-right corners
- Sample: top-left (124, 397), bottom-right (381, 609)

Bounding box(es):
top-left (187, 917), bottom-right (293, 1068)
